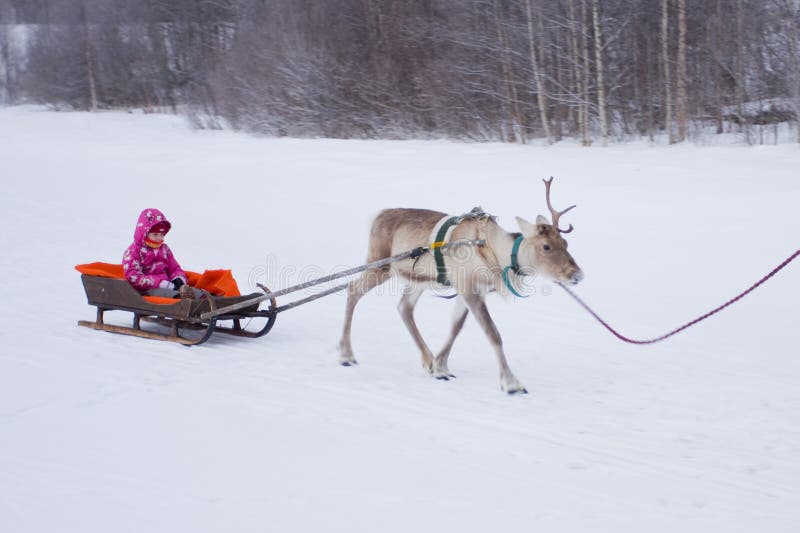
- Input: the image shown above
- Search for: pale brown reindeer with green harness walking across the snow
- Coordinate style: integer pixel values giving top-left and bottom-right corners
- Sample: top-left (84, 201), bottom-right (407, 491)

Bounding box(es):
top-left (339, 177), bottom-right (583, 394)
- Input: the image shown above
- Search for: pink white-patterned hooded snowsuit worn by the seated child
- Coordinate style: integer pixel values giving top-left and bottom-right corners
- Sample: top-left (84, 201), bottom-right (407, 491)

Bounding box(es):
top-left (122, 209), bottom-right (186, 292)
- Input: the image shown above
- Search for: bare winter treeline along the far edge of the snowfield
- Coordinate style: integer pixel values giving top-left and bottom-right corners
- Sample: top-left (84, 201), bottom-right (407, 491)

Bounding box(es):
top-left (0, 0), bottom-right (800, 144)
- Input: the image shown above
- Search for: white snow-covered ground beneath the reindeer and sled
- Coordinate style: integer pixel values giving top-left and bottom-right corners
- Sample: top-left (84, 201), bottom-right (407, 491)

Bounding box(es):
top-left (0, 108), bottom-right (800, 533)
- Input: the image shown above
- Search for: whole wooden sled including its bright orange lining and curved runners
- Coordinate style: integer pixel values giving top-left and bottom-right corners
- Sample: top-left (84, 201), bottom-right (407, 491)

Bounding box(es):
top-left (75, 263), bottom-right (277, 346)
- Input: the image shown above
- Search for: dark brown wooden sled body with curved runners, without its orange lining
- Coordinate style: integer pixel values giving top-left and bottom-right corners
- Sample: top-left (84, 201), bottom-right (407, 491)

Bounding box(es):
top-left (78, 268), bottom-right (277, 346)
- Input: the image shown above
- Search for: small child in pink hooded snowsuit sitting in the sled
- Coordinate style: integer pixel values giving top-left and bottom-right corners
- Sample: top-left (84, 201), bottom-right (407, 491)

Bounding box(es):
top-left (122, 209), bottom-right (201, 298)
